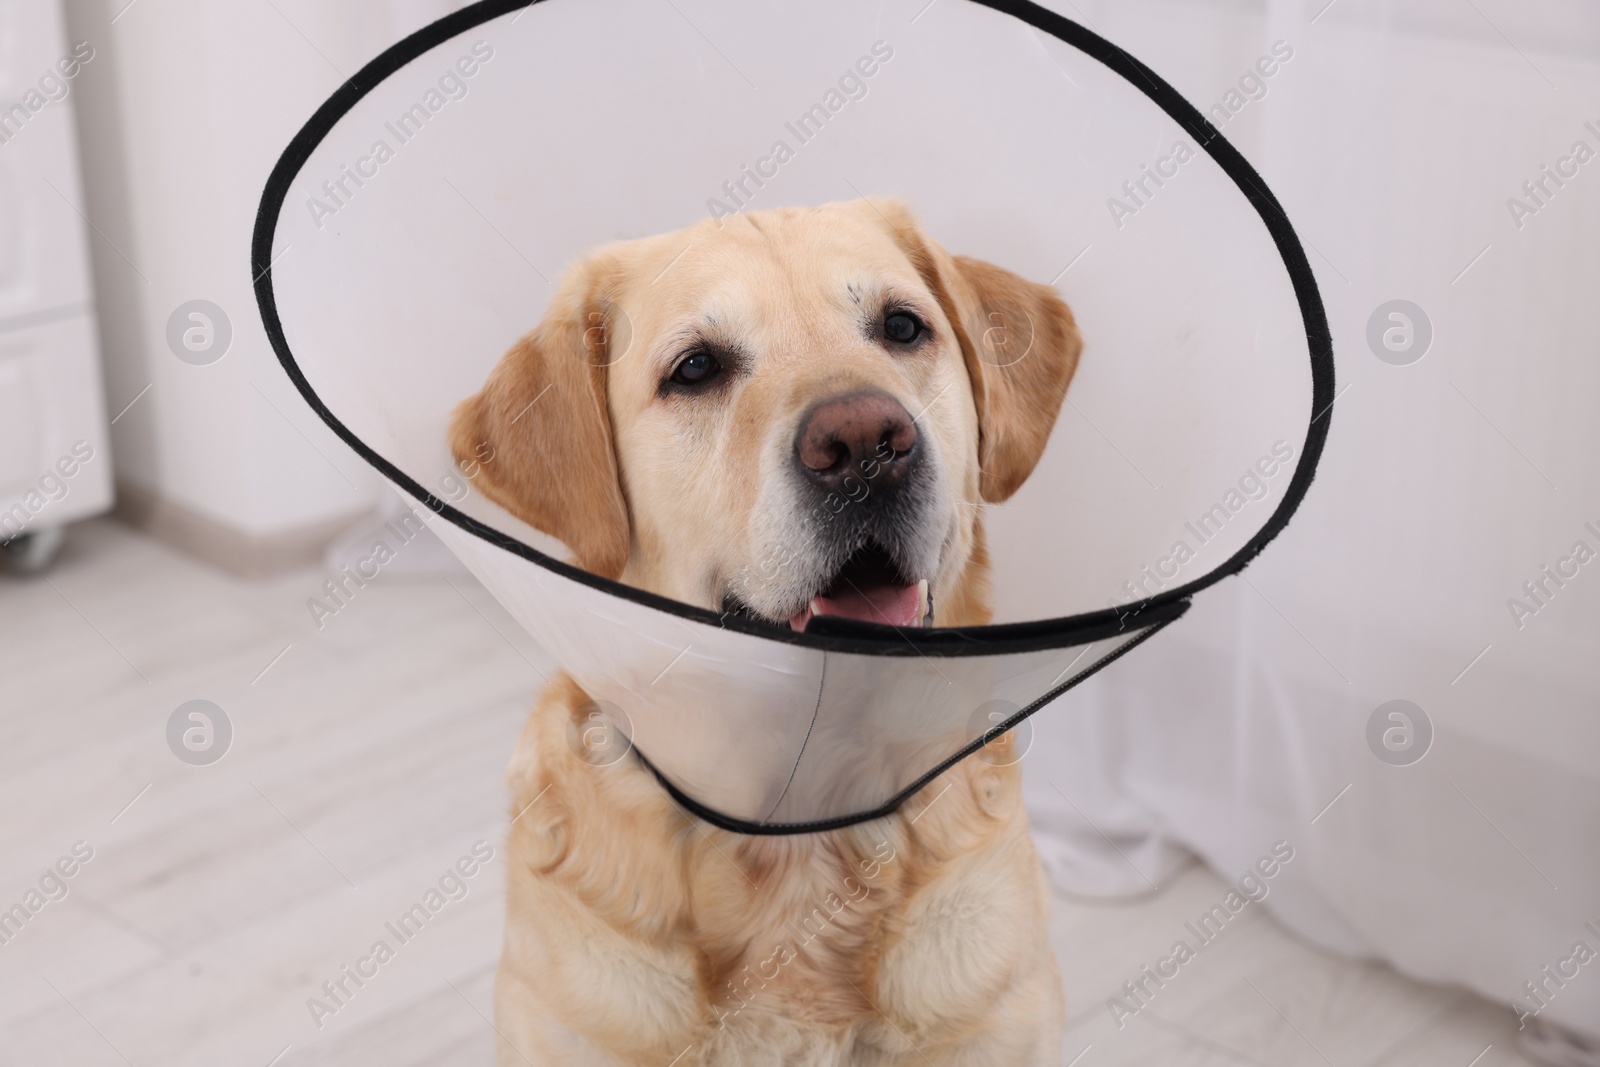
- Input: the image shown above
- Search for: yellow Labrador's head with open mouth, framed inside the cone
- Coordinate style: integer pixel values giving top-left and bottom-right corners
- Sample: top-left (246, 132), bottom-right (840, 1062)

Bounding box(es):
top-left (451, 202), bottom-right (1080, 629)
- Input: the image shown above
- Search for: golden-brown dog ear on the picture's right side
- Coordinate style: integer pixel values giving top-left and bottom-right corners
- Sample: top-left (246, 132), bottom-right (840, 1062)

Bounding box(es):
top-left (878, 202), bottom-right (1083, 504)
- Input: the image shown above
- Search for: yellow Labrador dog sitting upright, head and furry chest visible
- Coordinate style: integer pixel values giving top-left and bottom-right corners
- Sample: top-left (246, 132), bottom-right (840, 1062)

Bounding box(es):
top-left (451, 200), bottom-right (1082, 1067)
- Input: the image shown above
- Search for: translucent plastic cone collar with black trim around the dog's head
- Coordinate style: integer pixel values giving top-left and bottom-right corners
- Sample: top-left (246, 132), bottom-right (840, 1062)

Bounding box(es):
top-left (251, 0), bottom-right (1334, 833)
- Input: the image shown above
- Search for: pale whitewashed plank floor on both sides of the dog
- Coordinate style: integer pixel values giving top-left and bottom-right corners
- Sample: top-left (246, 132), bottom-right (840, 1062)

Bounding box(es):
top-left (0, 522), bottom-right (1548, 1067)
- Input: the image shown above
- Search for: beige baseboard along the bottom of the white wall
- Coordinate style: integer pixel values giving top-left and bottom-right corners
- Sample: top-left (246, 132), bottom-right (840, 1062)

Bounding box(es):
top-left (112, 482), bottom-right (371, 577)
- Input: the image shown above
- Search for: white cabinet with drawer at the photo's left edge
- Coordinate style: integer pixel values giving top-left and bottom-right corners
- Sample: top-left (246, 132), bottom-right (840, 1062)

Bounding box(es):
top-left (0, 0), bottom-right (115, 541)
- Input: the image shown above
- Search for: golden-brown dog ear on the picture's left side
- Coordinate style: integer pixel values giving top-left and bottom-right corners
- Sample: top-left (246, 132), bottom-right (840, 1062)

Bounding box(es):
top-left (450, 258), bottom-right (629, 577)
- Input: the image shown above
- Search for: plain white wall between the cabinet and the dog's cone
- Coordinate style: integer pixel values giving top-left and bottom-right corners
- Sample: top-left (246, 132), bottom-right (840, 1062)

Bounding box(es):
top-left (69, 0), bottom-right (467, 569)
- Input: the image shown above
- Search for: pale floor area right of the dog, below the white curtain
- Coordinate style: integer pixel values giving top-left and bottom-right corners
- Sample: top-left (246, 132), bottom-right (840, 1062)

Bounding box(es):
top-left (1051, 867), bottom-right (1530, 1067)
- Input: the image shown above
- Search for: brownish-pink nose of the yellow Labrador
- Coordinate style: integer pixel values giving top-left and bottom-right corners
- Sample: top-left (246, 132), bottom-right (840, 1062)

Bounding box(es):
top-left (795, 392), bottom-right (920, 493)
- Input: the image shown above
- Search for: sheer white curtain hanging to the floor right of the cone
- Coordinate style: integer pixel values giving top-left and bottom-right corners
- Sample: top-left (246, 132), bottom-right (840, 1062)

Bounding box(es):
top-left (1026, 0), bottom-right (1600, 1033)
